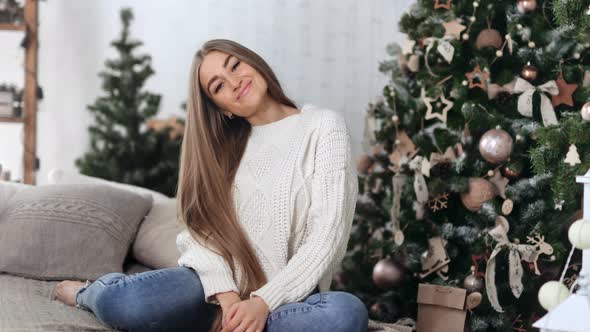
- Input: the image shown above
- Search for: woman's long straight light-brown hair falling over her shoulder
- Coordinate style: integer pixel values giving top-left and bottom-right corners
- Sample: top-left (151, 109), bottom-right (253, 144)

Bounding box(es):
top-left (176, 39), bottom-right (296, 332)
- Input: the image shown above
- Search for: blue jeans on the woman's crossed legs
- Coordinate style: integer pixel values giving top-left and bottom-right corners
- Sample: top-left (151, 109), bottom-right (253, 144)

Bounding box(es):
top-left (76, 266), bottom-right (368, 332)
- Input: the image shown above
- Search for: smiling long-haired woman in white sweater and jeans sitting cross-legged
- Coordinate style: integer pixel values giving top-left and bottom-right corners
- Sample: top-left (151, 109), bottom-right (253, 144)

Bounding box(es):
top-left (57, 39), bottom-right (368, 332)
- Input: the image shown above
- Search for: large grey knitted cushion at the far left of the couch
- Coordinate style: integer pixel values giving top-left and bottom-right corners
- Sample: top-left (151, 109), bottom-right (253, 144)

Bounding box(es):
top-left (0, 184), bottom-right (152, 280)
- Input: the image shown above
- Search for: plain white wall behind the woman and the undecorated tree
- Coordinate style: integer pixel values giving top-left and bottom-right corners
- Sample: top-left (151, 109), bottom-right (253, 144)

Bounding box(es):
top-left (0, 0), bottom-right (412, 184)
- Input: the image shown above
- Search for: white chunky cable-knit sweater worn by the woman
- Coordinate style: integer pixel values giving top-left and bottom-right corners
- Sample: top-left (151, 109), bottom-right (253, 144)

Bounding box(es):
top-left (176, 104), bottom-right (358, 311)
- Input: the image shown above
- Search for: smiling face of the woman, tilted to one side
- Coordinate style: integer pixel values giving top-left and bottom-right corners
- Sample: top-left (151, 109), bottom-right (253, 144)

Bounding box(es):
top-left (199, 51), bottom-right (267, 117)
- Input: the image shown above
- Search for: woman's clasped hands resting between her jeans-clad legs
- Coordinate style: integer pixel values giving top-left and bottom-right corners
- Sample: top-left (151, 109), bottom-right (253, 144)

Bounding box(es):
top-left (221, 296), bottom-right (269, 332)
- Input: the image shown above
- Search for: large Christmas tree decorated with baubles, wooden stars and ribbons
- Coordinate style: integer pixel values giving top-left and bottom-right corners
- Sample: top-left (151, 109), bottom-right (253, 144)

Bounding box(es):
top-left (336, 0), bottom-right (590, 331)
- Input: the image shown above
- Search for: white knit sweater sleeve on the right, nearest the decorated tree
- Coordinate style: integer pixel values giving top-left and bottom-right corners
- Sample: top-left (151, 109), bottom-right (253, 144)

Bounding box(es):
top-left (250, 111), bottom-right (358, 311)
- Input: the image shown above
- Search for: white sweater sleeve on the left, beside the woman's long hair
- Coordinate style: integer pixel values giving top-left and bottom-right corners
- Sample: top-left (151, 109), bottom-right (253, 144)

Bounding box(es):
top-left (176, 230), bottom-right (239, 304)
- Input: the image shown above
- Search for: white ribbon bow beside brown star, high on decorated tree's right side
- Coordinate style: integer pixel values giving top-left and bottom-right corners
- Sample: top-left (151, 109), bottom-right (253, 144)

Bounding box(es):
top-left (514, 77), bottom-right (559, 126)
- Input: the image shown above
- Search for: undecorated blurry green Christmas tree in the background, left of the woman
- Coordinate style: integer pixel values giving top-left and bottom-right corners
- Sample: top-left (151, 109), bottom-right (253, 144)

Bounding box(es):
top-left (76, 9), bottom-right (184, 196)
